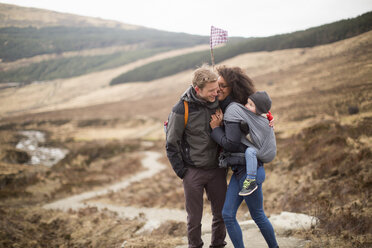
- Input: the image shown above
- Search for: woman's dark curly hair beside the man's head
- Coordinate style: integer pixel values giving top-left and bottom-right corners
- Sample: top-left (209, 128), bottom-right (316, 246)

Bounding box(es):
top-left (217, 66), bottom-right (256, 104)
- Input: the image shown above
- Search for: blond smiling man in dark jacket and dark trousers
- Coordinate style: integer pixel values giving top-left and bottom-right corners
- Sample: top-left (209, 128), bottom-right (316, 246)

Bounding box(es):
top-left (166, 66), bottom-right (226, 248)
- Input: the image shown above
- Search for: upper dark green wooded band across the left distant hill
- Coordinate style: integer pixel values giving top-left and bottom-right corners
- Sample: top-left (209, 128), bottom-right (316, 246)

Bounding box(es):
top-left (0, 26), bottom-right (208, 62)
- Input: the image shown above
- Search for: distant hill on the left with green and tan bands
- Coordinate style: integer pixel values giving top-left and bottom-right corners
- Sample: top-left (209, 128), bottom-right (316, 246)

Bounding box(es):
top-left (0, 4), bottom-right (215, 84)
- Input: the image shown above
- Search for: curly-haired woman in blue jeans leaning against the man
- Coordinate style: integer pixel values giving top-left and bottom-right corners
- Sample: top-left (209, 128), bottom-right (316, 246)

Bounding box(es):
top-left (210, 67), bottom-right (278, 248)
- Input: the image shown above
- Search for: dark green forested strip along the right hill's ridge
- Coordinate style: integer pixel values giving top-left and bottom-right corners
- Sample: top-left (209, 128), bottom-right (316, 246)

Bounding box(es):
top-left (111, 12), bottom-right (372, 85)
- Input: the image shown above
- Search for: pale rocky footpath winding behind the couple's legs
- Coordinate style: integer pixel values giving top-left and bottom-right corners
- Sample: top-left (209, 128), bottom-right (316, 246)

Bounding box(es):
top-left (43, 151), bottom-right (306, 248)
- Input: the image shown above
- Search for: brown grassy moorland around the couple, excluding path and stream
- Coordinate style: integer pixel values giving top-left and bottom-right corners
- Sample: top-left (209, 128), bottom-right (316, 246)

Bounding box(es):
top-left (0, 31), bottom-right (372, 248)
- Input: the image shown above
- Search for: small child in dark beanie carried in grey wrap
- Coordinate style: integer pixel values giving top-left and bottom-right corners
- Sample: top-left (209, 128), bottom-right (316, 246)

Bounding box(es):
top-left (239, 91), bottom-right (276, 196)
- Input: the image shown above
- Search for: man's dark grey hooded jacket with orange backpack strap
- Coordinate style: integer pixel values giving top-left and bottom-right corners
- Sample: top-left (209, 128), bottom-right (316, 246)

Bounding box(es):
top-left (166, 86), bottom-right (219, 178)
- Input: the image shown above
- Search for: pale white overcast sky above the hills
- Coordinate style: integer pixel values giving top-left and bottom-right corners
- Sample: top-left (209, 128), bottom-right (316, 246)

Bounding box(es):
top-left (0, 0), bottom-right (372, 37)
